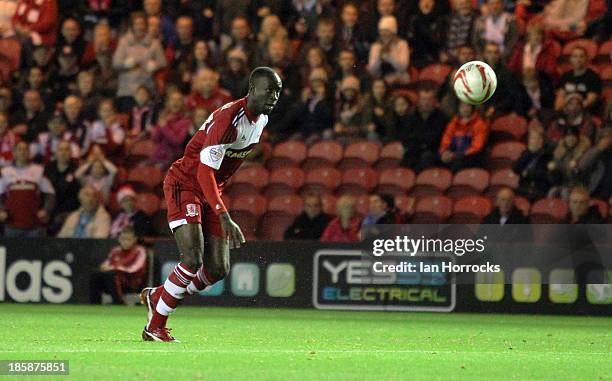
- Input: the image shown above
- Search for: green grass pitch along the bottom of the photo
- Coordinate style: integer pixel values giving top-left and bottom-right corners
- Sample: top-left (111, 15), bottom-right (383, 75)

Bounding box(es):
top-left (0, 304), bottom-right (612, 381)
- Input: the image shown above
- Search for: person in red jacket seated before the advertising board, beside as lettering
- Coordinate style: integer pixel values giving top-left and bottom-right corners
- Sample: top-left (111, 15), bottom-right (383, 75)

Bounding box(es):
top-left (90, 225), bottom-right (147, 304)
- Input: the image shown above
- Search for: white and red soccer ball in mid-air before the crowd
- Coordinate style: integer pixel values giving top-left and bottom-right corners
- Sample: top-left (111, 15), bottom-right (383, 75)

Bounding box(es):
top-left (453, 61), bottom-right (497, 105)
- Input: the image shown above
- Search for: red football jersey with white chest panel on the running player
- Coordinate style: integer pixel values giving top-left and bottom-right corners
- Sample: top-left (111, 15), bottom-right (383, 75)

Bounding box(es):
top-left (166, 98), bottom-right (268, 194)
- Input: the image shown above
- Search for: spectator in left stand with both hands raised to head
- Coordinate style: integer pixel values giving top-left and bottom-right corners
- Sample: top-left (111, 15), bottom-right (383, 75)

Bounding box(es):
top-left (75, 146), bottom-right (117, 203)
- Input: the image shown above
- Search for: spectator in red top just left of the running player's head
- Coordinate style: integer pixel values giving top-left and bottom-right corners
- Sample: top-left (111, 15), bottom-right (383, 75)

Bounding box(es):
top-left (187, 68), bottom-right (232, 112)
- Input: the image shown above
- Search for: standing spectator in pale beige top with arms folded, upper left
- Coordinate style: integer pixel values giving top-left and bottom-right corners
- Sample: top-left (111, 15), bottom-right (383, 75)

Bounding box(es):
top-left (113, 11), bottom-right (166, 111)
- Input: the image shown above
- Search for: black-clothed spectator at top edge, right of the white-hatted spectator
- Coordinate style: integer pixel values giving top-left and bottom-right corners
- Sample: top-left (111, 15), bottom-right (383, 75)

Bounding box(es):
top-left (408, 0), bottom-right (447, 68)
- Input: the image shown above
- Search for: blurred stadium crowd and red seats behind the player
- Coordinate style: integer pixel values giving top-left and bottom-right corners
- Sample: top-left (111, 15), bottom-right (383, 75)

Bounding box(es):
top-left (0, 0), bottom-right (612, 242)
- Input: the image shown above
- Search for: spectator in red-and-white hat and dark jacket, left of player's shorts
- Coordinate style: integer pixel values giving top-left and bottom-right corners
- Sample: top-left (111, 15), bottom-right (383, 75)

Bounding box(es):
top-left (110, 186), bottom-right (153, 238)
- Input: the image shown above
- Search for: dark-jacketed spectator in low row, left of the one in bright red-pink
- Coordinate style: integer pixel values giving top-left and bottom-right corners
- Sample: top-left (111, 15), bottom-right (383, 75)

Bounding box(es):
top-left (285, 195), bottom-right (331, 240)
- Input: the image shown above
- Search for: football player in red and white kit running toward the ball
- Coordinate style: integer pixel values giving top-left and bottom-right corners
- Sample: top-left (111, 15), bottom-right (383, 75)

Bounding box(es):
top-left (140, 67), bottom-right (282, 342)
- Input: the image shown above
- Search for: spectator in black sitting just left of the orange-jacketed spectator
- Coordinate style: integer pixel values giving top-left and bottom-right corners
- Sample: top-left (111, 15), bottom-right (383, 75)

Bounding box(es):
top-left (398, 89), bottom-right (448, 171)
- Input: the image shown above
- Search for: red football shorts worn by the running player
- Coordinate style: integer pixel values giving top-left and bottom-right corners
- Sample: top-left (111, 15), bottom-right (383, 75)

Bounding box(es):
top-left (164, 180), bottom-right (223, 237)
